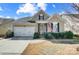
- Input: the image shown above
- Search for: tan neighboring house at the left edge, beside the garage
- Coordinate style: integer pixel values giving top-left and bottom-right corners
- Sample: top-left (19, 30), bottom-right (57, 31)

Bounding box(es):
top-left (0, 18), bottom-right (14, 36)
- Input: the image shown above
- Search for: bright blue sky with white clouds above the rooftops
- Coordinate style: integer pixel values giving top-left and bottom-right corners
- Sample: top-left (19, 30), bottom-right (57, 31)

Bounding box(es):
top-left (0, 3), bottom-right (77, 19)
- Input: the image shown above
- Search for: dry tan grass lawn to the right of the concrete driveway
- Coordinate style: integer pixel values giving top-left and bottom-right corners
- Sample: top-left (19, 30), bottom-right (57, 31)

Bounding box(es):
top-left (22, 40), bottom-right (79, 55)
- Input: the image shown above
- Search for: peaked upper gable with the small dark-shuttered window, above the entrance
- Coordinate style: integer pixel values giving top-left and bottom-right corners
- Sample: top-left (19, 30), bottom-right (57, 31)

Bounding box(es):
top-left (31, 10), bottom-right (49, 21)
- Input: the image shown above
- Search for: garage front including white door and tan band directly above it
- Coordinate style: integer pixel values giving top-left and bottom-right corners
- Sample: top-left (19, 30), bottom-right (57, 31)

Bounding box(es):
top-left (14, 21), bottom-right (35, 36)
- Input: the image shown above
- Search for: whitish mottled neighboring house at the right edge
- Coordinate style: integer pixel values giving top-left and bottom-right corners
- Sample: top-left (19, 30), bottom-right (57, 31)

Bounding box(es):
top-left (62, 14), bottom-right (79, 35)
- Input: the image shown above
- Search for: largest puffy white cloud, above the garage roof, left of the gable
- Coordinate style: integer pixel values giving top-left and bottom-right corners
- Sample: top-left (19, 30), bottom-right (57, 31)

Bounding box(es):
top-left (16, 3), bottom-right (36, 15)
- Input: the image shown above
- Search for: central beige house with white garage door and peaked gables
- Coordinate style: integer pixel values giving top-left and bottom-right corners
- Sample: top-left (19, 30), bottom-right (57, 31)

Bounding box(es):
top-left (13, 10), bottom-right (64, 36)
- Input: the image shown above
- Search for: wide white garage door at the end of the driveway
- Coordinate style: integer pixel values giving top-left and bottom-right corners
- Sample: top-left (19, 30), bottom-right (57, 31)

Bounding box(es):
top-left (14, 27), bottom-right (35, 36)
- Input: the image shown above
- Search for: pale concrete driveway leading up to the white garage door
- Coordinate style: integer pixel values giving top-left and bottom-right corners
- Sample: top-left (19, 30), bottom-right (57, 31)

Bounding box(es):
top-left (0, 39), bottom-right (30, 55)
